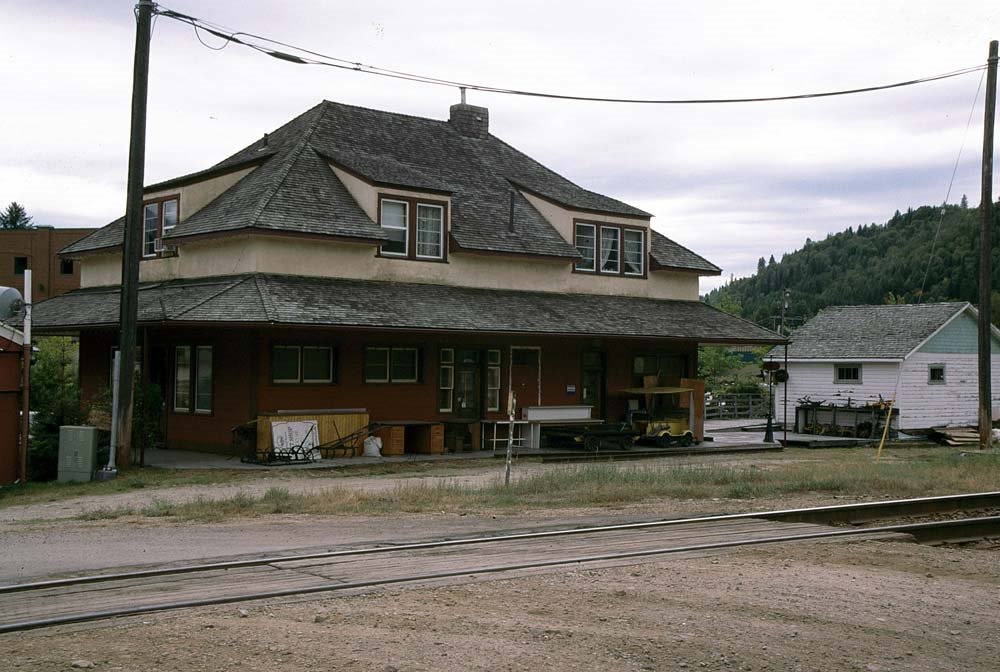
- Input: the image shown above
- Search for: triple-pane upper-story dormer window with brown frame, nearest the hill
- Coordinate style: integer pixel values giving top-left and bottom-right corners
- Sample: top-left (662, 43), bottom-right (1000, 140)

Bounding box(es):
top-left (573, 222), bottom-right (646, 278)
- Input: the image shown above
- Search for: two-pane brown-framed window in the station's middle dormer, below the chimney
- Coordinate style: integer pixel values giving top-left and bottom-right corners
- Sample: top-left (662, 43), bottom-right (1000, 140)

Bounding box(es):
top-left (379, 197), bottom-right (447, 261)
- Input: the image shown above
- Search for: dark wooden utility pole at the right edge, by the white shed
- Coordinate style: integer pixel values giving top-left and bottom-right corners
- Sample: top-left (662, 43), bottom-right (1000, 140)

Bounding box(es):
top-left (979, 40), bottom-right (997, 450)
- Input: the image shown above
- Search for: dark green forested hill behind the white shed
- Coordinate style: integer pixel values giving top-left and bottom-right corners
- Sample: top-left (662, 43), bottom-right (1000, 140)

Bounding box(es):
top-left (704, 197), bottom-right (1000, 328)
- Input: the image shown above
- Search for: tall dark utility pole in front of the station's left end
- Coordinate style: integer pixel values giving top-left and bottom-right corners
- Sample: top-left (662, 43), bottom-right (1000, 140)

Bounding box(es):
top-left (112, 0), bottom-right (153, 467)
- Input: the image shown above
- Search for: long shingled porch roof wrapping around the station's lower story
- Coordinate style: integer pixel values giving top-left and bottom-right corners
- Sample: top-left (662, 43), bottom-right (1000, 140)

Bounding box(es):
top-left (33, 273), bottom-right (784, 344)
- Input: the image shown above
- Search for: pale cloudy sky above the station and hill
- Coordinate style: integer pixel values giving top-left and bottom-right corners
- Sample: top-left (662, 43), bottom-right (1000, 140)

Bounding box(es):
top-left (0, 0), bottom-right (1000, 292)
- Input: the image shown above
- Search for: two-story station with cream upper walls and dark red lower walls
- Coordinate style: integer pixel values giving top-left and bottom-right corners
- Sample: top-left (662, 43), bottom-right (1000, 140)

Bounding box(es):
top-left (34, 101), bottom-right (782, 451)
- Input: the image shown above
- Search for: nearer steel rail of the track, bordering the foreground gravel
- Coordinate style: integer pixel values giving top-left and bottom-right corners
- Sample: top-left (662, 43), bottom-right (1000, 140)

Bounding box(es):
top-left (0, 516), bottom-right (1000, 634)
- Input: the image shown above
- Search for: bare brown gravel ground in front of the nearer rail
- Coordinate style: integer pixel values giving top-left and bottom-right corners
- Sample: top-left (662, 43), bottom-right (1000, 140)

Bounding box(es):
top-left (0, 541), bottom-right (1000, 672)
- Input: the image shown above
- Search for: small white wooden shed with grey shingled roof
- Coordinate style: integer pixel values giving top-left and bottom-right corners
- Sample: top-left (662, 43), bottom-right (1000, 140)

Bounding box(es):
top-left (768, 303), bottom-right (1000, 430)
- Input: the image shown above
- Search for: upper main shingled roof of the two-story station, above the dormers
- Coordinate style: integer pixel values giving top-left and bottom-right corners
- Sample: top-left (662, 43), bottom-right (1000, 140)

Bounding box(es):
top-left (62, 101), bottom-right (719, 273)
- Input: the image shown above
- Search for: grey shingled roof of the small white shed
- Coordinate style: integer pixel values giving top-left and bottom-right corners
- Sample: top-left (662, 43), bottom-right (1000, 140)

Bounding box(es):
top-left (773, 302), bottom-right (969, 360)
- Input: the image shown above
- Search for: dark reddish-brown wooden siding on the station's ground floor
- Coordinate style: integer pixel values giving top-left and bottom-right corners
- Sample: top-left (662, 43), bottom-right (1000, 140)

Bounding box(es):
top-left (80, 327), bottom-right (696, 452)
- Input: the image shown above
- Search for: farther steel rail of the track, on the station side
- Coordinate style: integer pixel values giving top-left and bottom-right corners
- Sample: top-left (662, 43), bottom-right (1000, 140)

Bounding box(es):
top-left (0, 491), bottom-right (1000, 595)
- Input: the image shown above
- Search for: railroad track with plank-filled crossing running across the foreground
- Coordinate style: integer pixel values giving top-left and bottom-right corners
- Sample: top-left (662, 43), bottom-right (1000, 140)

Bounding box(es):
top-left (0, 492), bottom-right (1000, 633)
